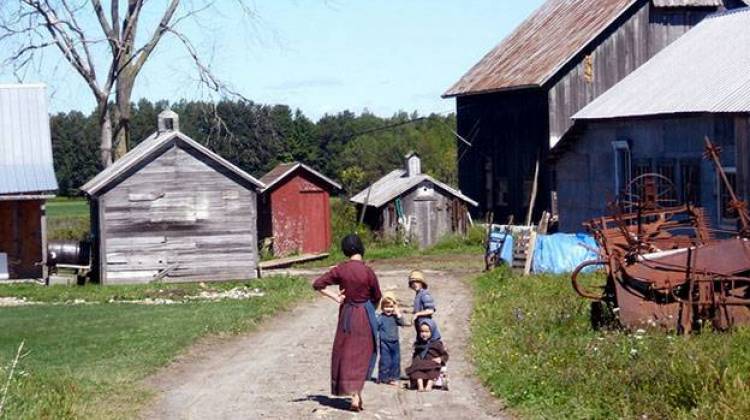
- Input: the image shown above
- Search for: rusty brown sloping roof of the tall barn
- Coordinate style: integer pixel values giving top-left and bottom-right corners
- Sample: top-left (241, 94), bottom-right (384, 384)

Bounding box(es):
top-left (443, 0), bottom-right (643, 97)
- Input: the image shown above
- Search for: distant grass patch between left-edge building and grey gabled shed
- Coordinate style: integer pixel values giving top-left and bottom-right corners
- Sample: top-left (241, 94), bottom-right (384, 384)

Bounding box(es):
top-left (47, 197), bottom-right (90, 240)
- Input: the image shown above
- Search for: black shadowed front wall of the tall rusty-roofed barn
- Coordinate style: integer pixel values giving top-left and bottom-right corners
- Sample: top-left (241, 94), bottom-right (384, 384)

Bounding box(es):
top-left (457, 89), bottom-right (549, 222)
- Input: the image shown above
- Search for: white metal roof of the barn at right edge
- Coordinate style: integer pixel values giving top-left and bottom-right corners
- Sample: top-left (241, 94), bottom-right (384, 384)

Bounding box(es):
top-left (573, 8), bottom-right (750, 120)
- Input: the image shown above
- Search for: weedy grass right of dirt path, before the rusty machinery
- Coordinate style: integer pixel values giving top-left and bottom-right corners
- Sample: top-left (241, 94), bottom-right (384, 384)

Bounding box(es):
top-left (472, 269), bottom-right (750, 418)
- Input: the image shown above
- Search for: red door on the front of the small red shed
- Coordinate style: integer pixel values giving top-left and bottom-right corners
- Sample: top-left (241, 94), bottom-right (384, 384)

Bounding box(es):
top-left (300, 191), bottom-right (330, 253)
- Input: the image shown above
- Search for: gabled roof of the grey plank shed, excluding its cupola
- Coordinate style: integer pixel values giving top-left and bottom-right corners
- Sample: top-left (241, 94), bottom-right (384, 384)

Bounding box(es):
top-left (81, 131), bottom-right (265, 195)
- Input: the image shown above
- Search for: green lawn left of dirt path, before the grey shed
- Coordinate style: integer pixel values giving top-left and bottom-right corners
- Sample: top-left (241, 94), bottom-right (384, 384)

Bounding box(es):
top-left (0, 277), bottom-right (312, 419)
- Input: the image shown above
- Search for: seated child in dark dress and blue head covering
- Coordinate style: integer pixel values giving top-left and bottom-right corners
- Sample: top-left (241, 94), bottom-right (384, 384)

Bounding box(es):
top-left (406, 319), bottom-right (448, 392)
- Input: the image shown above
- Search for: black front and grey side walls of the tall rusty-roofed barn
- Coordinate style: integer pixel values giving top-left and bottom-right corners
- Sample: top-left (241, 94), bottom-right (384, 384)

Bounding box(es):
top-left (456, 1), bottom-right (716, 222)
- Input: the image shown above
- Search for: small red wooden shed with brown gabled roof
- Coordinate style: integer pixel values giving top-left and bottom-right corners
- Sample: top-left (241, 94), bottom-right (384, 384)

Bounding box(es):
top-left (258, 162), bottom-right (341, 257)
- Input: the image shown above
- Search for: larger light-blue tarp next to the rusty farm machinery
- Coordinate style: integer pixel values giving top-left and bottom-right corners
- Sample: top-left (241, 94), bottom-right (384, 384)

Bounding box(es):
top-left (532, 233), bottom-right (599, 274)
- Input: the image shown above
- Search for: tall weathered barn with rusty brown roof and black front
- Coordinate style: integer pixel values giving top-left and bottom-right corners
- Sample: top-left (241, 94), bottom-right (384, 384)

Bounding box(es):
top-left (444, 0), bottom-right (743, 221)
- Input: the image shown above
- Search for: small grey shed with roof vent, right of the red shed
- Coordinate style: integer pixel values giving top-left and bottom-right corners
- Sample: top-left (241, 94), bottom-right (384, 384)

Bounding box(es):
top-left (351, 153), bottom-right (477, 247)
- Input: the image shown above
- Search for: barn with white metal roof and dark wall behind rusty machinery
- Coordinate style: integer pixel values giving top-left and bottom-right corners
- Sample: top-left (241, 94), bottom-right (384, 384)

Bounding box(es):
top-left (552, 8), bottom-right (750, 230)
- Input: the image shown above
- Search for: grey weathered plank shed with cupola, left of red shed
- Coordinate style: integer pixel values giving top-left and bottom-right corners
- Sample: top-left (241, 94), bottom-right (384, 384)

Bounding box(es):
top-left (81, 111), bottom-right (263, 284)
